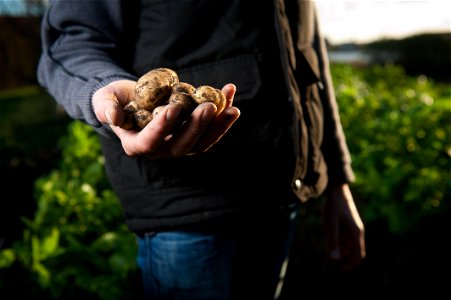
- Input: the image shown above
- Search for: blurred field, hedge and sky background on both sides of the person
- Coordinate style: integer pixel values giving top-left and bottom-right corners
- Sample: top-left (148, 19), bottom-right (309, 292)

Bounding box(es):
top-left (0, 0), bottom-right (451, 299)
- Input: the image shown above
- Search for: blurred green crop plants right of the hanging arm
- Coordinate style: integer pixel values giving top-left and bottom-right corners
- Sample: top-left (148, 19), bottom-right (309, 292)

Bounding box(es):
top-left (332, 64), bottom-right (451, 232)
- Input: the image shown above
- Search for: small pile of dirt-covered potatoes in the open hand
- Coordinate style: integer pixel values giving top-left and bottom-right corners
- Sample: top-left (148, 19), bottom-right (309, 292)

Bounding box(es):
top-left (121, 68), bottom-right (226, 130)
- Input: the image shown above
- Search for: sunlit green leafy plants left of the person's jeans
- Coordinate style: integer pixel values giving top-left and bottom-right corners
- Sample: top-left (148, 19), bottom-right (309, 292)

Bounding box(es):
top-left (0, 122), bottom-right (136, 299)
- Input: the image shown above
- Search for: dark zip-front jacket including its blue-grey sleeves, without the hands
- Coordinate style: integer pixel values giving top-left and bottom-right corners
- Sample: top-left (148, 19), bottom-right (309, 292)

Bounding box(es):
top-left (38, 0), bottom-right (353, 231)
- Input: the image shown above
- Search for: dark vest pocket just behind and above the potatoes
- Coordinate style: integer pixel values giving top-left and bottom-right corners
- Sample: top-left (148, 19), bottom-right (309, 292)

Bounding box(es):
top-left (177, 55), bottom-right (261, 101)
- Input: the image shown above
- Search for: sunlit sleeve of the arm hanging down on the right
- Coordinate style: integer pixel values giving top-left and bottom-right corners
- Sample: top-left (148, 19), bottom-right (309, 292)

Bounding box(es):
top-left (314, 6), bottom-right (355, 186)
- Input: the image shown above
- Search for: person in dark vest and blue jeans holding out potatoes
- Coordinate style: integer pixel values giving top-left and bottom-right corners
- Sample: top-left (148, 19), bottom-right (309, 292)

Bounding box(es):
top-left (37, 0), bottom-right (365, 300)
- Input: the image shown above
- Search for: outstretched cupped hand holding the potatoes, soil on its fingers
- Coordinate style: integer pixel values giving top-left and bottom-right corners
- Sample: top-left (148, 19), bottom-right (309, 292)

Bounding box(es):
top-left (92, 80), bottom-right (240, 159)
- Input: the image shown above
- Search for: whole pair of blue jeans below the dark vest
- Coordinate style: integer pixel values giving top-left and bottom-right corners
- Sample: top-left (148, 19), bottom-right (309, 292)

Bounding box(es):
top-left (137, 205), bottom-right (298, 300)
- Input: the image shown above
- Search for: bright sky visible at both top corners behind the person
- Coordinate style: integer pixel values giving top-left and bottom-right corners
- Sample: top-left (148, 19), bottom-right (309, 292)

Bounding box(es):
top-left (0, 0), bottom-right (451, 44)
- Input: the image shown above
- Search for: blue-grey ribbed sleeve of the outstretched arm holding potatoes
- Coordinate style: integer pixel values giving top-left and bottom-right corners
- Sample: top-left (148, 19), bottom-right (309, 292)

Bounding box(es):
top-left (37, 0), bottom-right (136, 134)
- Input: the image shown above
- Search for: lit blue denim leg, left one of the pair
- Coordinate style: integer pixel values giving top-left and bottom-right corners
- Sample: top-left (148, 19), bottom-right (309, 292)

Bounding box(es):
top-left (137, 231), bottom-right (234, 300)
